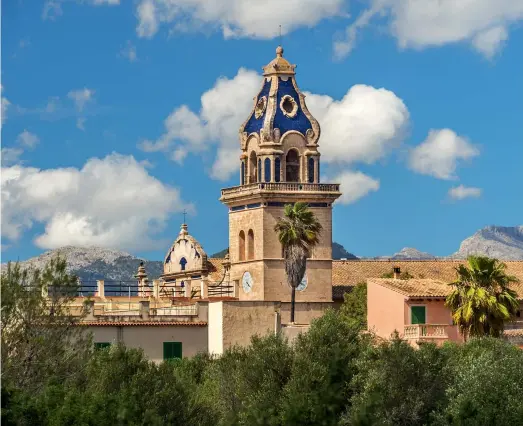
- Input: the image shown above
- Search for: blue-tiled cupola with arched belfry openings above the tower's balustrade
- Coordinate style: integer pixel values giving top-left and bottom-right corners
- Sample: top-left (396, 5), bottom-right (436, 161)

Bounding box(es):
top-left (240, 46), bottom-right (320, 185)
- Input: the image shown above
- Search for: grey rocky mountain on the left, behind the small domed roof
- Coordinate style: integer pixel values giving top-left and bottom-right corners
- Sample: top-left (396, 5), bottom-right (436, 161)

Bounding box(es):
top-left (2, 246), bottom-right (163, 281)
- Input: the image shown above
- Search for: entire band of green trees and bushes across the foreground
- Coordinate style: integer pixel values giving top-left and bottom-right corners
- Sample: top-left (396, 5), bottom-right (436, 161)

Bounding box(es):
top-left (1, 256), bottom-right (523, 426)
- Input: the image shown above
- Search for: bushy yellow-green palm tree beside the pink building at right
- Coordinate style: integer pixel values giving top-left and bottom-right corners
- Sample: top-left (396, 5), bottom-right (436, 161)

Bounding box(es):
top-left (445, 256), bottom-right (519, 339)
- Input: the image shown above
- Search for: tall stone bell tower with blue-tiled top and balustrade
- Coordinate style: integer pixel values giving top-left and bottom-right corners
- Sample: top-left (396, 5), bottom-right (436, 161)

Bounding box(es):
top-left (220, 46), bottom-right (341, 302)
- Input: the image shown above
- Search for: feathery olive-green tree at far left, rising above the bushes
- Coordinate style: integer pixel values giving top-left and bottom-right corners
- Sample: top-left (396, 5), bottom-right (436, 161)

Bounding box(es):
top-left (1, 257), bottom-right (91, 392)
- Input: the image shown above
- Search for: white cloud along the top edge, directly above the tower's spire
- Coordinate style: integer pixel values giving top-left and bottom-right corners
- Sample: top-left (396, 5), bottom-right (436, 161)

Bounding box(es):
top-left (136, 0), bottom-right (346, 39)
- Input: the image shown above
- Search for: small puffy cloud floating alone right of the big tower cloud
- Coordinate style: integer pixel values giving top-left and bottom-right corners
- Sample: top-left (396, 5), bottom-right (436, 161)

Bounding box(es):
top-left (409, 129), bottom-right (479, 179)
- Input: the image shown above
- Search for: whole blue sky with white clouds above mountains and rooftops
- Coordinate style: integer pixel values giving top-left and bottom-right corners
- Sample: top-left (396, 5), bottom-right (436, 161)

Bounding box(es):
top-left (1, 0), bottom-right (523, 261)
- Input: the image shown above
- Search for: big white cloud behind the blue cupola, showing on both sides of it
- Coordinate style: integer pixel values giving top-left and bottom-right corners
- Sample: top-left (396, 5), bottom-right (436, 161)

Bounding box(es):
top-left (139, 68), bottom-right (409, 188)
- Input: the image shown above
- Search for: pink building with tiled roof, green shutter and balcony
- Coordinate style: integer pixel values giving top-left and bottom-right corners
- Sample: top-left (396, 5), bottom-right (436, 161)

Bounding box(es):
top-left (367, 278), bottom-right (523, 348)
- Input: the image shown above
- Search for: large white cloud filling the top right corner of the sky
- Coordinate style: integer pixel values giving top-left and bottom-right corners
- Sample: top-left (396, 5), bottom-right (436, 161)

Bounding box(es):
top-left (334, 0), bottom-right (523, 58)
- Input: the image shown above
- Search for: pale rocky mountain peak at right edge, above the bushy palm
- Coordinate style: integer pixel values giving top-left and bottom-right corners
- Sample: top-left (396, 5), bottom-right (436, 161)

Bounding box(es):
top-left (451, 225), bottom-right (523, 260)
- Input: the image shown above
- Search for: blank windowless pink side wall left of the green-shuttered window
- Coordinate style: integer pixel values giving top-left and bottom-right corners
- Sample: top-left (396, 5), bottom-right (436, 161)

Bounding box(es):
top-left (367, 281), bottom-right (406, 339)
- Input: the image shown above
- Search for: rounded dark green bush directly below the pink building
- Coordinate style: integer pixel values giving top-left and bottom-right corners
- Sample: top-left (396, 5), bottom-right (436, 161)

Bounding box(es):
top-left (346, 338), bottom-right (446, 426)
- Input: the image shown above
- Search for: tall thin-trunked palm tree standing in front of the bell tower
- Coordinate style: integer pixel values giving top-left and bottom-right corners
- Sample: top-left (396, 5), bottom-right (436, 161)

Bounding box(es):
top-left (274, 202), bottom-right (322, 323)
